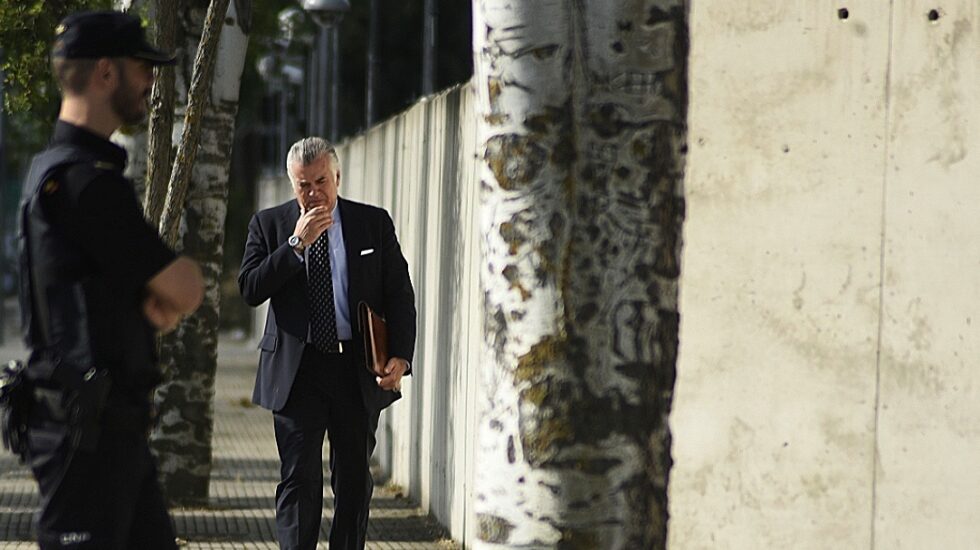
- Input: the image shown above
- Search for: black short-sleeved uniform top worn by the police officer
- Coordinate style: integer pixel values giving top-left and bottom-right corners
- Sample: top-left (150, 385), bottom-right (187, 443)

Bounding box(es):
top-left (20, 120), bottom-right (175, 404)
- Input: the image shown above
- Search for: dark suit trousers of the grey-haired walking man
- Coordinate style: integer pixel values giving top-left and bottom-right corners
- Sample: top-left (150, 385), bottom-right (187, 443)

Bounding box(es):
top-left (274, 346), bottom-right (379, 550)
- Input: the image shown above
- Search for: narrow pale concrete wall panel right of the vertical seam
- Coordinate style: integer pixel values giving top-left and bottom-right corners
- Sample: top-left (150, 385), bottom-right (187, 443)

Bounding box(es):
top-left (875, 0), bottom-right (980, 550)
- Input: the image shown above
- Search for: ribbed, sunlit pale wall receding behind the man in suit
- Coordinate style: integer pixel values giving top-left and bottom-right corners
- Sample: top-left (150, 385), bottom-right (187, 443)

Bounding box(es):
top-left (339, 87), bottom-right (483, 539)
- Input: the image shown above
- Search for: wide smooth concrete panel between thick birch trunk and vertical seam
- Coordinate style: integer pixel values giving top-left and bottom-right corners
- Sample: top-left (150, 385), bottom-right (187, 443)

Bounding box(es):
top-left (669, 0), bottom-right (889, 550)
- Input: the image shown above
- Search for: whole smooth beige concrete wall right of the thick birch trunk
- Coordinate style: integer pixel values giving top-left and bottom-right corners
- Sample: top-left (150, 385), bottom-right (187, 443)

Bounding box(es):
top-left (669, 0), bottom-right (980, 550)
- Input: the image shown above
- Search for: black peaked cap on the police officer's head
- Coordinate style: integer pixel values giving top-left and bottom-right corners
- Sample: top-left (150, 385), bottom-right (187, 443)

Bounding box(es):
top-left (51, 11), bottom-right (176, 65)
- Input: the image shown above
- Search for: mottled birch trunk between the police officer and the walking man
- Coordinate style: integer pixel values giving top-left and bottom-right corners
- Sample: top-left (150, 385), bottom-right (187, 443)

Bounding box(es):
top-left (151, 0), bottom-right (251, 504)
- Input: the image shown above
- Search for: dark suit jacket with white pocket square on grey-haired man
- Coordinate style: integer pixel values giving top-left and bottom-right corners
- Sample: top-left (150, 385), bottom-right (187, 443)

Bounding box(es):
top-left (238, 198), bottom-right (416, 411)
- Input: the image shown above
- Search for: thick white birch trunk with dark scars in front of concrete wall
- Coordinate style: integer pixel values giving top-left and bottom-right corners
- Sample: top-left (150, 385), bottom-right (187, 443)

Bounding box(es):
top-left (473, 0), bottom-right (688, 549)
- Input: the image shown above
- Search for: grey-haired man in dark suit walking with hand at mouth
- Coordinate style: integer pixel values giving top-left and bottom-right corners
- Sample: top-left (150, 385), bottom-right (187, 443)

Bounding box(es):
top-left (238, 137), bottom-right (416, 550)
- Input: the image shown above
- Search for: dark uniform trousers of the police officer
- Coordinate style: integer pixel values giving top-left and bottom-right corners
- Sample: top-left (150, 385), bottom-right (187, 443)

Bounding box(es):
top-left (28, 406), bottom-right (177, 550)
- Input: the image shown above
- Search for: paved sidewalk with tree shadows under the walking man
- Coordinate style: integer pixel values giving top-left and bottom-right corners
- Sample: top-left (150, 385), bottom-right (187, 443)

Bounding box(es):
top-left (0, 338), bottom-right (458, 550)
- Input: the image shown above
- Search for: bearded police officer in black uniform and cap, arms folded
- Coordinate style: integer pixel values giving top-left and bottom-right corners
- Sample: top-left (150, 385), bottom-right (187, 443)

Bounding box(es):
top-left (20, 11), bottom-right (203, 550)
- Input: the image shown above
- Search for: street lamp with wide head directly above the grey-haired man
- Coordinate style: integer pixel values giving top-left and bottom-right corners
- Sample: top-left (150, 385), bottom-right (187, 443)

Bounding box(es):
top-left (303, 0), bottom-right (350, 140)
